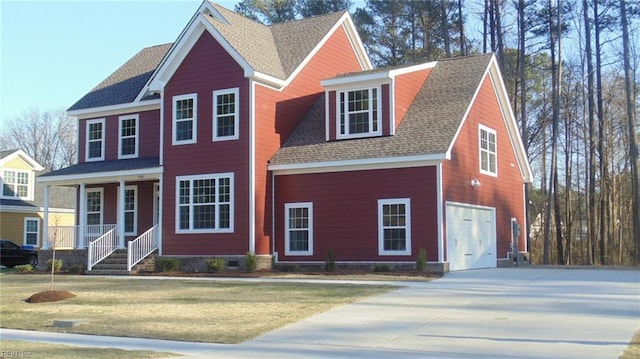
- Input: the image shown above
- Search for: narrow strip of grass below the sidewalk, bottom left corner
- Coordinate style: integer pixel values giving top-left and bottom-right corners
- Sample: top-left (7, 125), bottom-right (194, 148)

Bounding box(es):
top-left (0, 340), bottom-right (180, 359)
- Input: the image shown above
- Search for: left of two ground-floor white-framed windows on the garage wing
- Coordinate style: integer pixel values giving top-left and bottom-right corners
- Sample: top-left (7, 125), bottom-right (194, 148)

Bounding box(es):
top-left (284, 202), bottom-right (313, 255)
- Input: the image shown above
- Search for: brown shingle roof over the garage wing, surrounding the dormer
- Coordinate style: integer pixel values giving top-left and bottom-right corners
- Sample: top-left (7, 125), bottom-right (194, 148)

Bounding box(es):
top-left (270, 54), bottom-right (492, 165)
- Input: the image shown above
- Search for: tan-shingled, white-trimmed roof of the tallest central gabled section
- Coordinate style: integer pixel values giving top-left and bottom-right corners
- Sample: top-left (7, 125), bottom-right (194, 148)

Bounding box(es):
top-left (148, 1), bottom-right (364, 91)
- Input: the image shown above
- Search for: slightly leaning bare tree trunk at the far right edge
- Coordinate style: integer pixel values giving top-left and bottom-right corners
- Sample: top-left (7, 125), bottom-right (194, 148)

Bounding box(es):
top-left (620, 0), bottom-right (640, 264)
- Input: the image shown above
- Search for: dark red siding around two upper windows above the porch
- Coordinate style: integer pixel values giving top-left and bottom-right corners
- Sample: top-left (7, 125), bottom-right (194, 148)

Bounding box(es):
top-left (78, 110), bottom-right (160, 163)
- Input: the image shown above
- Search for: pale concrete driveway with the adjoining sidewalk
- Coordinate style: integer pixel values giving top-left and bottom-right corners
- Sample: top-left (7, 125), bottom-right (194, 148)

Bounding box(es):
top-left (0, 268), bottom-right (640, 359)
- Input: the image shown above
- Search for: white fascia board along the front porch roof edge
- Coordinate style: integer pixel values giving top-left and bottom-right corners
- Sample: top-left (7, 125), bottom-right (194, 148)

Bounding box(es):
top-left (36, 167), bottom-right (163, 186)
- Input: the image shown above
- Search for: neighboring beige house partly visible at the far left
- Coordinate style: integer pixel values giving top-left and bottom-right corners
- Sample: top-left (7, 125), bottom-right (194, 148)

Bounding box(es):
top-left (0, 150), bottom-right (76, 248)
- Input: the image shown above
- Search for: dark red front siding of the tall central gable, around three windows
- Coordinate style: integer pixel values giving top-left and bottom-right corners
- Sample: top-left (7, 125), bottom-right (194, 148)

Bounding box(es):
top-left (163, 31), bottom-right (249, 255)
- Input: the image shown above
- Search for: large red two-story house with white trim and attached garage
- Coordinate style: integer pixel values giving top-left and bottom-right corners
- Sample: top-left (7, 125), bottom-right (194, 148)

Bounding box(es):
top-left (39, 1), bottom-right (531, 270)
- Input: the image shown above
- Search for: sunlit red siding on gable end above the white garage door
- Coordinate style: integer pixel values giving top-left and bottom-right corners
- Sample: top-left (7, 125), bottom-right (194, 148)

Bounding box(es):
top-left (443, 76), bottom-right (525, 258)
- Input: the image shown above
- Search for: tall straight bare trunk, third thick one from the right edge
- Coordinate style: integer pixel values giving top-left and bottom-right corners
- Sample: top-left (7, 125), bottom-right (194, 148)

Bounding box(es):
top-left (582, 0), bottom-right (597, 265)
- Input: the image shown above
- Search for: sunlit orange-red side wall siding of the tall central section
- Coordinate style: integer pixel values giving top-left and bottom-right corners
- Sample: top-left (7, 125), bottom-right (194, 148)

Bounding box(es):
top-left (255, 27), bottom-right (362, 254)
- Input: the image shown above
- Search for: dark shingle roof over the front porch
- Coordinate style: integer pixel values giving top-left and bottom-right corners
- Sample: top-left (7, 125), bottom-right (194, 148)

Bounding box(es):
top-left (39, 157), bottom-right (160, 177)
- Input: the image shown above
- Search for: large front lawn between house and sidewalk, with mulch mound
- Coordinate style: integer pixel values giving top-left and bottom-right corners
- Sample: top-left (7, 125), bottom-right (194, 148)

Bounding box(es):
top-left (0, 274), bottom-right (397, 343)
